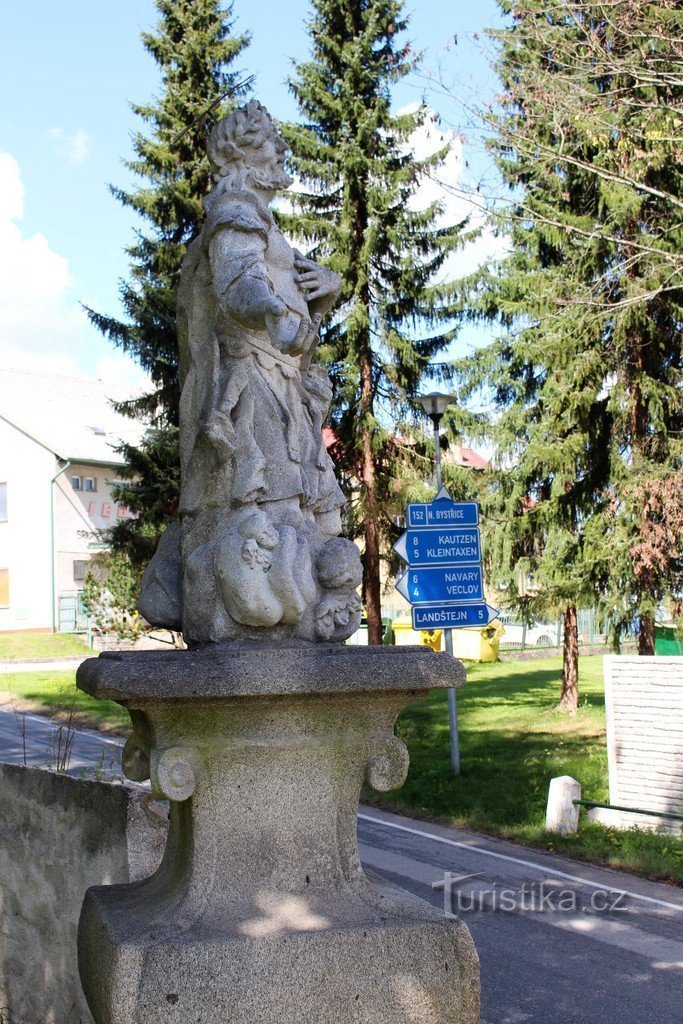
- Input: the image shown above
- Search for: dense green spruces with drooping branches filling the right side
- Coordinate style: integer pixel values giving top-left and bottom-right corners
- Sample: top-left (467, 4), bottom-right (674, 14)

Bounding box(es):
top-left (454, 0), bottom-right (683, 688)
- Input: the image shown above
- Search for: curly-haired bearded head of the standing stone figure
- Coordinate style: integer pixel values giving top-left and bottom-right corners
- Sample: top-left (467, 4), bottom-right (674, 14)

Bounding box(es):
top-left (207, 99), bottom-right (292, 193)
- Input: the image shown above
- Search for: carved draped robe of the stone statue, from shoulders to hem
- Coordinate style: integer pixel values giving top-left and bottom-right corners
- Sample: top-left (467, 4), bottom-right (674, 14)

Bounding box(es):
top-left (178, 183), bottom-right (345, 515)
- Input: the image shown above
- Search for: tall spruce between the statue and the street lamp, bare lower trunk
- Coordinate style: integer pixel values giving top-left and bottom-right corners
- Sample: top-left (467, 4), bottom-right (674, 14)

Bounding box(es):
top-left (283, 0), bottom-right (458, 643)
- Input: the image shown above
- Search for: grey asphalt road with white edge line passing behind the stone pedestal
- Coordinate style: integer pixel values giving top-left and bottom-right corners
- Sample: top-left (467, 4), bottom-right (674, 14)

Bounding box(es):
top-left (0, 709), bottom-right (683, 1024)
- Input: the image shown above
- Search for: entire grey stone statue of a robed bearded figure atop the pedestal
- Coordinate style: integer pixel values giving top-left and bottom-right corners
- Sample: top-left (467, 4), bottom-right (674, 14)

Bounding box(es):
top-left (139, 100), bottom-right (361, 644)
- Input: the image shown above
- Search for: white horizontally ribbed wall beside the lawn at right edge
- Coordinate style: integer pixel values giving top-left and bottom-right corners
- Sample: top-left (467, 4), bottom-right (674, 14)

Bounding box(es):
top-left (602, 655), bottom-right (683, 833)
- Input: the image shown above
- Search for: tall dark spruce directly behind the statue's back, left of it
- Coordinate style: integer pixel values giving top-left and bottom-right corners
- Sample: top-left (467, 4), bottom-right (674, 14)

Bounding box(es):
top-left (88, 0), bottom-right (249, 564)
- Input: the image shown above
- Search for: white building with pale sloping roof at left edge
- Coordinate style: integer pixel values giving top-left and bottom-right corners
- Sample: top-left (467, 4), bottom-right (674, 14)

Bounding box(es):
top-left (0, 369), bottom-right (140, 632)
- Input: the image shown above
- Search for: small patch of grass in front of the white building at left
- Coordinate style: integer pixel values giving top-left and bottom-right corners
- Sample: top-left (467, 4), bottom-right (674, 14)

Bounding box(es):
top-left (0, 671), bottom-right (130, 732)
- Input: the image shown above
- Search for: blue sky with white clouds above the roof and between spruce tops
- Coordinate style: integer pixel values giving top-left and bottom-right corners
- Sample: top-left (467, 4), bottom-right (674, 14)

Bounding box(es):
top-left (0, 0), bottom-right (500, 392)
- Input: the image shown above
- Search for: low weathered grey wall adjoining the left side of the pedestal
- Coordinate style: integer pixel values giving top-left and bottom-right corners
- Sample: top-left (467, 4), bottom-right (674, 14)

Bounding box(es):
top-left (0, 764), bottom-right (167, 1024)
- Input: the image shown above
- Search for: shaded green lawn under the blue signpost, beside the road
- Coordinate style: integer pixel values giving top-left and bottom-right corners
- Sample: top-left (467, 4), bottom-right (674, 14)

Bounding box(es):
top-left (364, 656), bottom-right (683, 883)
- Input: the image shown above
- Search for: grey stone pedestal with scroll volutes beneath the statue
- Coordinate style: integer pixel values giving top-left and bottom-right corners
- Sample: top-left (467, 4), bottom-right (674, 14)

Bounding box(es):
top-left (78, 644), bottom-right (479, 1024)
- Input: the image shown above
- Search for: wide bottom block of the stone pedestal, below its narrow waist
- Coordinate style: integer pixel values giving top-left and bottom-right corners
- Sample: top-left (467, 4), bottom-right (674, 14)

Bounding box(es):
top-left (81, 883), bottom-right (479, 1024)
